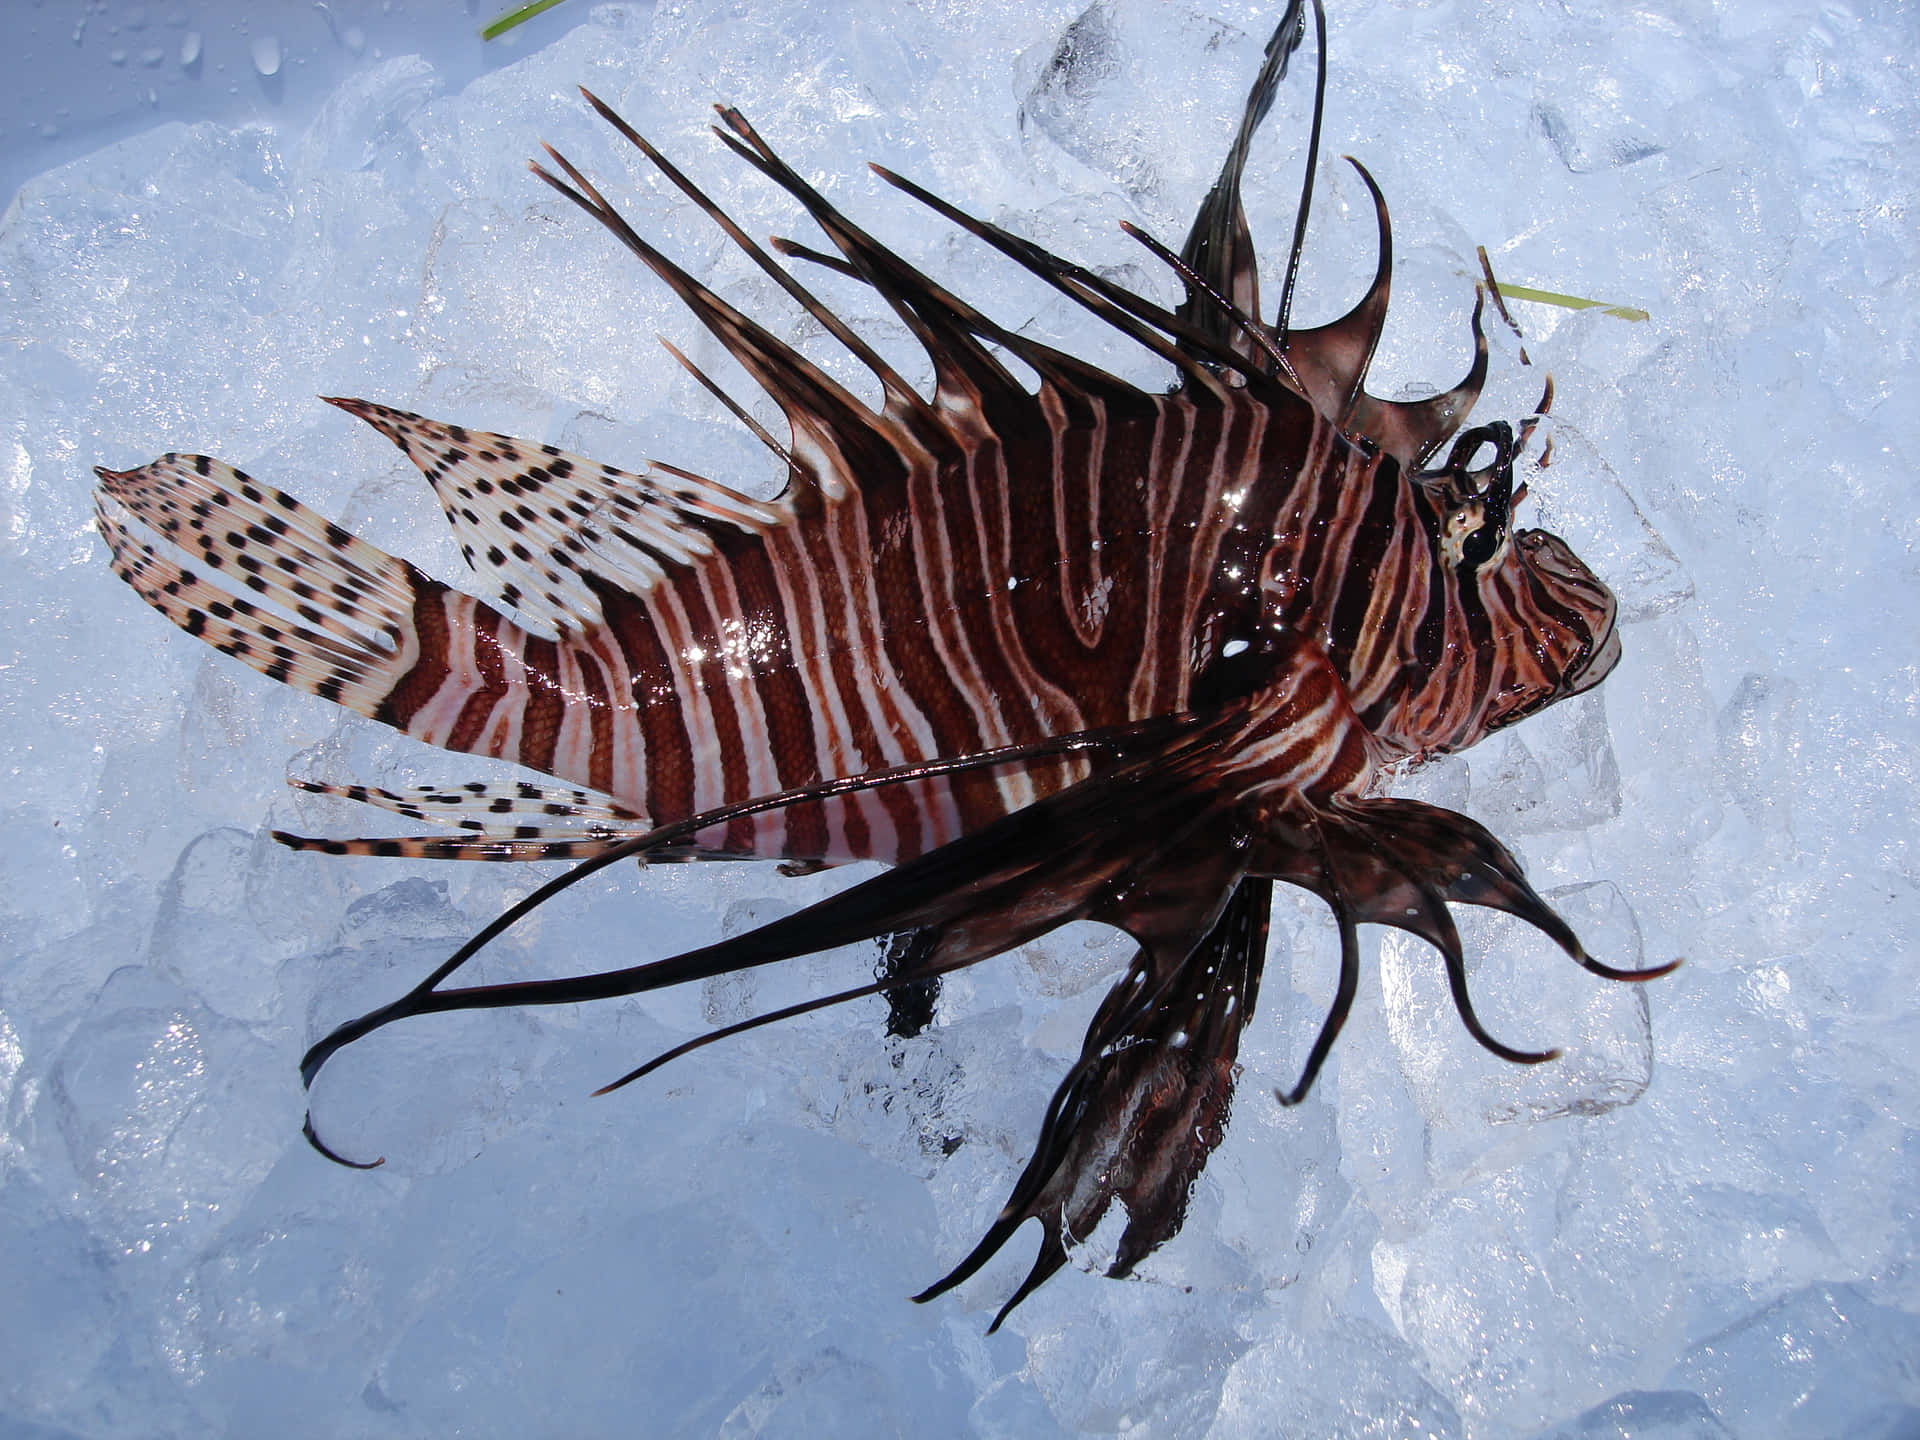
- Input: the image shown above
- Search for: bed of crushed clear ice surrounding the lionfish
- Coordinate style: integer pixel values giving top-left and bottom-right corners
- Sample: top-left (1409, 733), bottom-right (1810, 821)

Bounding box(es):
top-left (0, 0), bottom-right (1920, 1440)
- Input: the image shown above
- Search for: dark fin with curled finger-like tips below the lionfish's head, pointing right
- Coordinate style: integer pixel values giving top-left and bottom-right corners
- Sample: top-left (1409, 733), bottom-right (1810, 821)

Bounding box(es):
top-left (1250, 797), bottom-right (1680, 1104)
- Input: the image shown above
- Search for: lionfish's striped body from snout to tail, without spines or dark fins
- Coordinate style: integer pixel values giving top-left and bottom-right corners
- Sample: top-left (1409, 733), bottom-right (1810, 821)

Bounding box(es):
top-left (93, 362), bottom-right (1617, 864)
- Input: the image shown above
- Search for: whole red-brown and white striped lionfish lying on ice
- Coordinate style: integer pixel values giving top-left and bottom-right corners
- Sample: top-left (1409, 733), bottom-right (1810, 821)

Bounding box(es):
top-left (98, 0), bottom-right (1668, 1327)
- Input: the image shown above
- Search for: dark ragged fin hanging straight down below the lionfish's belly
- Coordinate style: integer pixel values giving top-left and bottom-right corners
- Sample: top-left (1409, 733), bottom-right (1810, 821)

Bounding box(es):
top-left (914, 879), bottom-right (1273, 1334)
